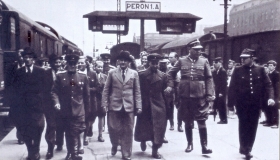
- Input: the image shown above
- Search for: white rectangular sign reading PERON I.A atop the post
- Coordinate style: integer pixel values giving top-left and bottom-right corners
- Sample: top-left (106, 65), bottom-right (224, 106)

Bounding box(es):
top-left (125, 1), bottom-right (161, 12)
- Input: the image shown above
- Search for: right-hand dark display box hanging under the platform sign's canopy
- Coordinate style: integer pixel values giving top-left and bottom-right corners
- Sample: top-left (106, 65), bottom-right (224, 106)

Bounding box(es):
top-left (156, 19), bottom-right (196, 34)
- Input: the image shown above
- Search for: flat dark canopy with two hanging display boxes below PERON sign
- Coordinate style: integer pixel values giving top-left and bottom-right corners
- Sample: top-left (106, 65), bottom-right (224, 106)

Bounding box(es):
top-left (83, 11), bottom-right (201, 35)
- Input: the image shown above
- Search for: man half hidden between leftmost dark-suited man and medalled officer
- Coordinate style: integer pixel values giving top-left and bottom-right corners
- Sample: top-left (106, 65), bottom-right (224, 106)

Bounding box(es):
top-left (43, 54), bottom-right (64, 159)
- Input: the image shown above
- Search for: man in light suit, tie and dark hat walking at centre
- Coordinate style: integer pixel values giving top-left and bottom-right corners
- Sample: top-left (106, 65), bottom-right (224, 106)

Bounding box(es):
top-left (102, 51), bottom-right (142, 160)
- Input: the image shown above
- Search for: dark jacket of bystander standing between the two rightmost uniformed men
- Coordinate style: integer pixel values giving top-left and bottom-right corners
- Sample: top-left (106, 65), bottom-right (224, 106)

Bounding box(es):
top-left (212, 67), bottom-right (227, 98)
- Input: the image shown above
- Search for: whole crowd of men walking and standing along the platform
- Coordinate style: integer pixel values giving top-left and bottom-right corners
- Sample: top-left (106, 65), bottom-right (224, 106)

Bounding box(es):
top-left (6, 41), bottom-right (279, 160)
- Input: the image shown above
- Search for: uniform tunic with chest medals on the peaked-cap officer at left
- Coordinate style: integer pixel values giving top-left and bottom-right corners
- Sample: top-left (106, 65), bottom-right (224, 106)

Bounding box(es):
top-left (52, 71), bottom-right (90, 121)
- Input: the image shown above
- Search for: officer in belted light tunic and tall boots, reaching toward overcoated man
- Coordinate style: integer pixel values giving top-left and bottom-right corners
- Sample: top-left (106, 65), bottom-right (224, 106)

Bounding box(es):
top-left (166, 41), bottom-right (214, 154)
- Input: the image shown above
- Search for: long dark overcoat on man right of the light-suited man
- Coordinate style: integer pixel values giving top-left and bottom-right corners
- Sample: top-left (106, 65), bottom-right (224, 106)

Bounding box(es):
top-left (134, 68), bottom-right (168, 145)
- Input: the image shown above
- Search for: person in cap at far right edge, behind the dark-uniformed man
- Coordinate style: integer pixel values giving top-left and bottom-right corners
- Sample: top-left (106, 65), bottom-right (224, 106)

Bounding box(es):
top-left (264, 60), bottom-right (280, 128)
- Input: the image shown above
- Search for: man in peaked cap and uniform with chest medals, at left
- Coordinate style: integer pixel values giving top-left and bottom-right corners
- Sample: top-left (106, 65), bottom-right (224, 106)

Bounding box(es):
top-left (52, 52), bottom-right (90, 160)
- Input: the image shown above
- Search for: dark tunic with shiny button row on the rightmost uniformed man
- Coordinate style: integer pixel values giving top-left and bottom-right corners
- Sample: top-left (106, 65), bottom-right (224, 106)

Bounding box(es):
top-left (228, 65), bottom-right (274, 109)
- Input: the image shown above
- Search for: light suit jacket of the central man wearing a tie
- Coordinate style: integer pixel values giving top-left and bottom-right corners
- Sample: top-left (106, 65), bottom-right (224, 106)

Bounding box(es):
top-left (102, 68), bottom-right (142, 112)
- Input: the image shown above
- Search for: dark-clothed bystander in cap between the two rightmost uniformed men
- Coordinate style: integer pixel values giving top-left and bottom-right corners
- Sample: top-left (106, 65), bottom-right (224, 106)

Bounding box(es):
top-left (212, 57), bottom-right (227, 124)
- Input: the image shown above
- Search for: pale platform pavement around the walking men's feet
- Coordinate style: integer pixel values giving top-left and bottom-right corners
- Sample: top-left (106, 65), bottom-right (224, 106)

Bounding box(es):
top-left (0, 109), bottom-right (279, 160)
